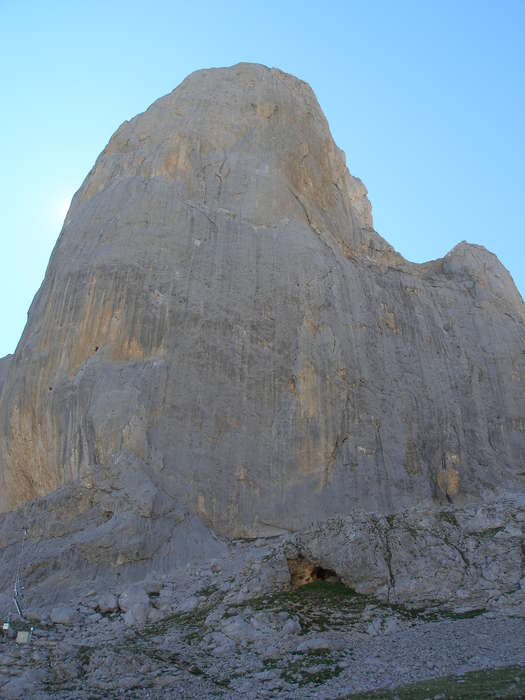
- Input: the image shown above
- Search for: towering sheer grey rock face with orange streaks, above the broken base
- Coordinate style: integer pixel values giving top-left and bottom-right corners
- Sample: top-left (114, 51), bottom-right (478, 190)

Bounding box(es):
top-left (0, 64), bottom-right (525, 536)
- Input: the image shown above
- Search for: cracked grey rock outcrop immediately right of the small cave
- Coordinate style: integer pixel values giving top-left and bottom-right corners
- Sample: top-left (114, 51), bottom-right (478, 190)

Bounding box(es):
top-left (290, 502), bottom-right (523, 609)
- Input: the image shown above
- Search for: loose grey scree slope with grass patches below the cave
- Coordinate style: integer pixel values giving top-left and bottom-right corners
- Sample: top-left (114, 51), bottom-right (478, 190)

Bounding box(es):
top-left (0, 582), bottom-right (525, 698)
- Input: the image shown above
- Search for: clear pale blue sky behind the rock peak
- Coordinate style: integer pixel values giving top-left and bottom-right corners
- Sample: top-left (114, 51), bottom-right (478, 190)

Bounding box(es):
top-left (0, 0), bottom-right (525, 356)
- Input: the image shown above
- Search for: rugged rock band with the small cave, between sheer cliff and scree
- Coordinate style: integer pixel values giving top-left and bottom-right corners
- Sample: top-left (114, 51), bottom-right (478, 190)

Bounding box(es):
top-left (0, 474), bottom-right (525, 620)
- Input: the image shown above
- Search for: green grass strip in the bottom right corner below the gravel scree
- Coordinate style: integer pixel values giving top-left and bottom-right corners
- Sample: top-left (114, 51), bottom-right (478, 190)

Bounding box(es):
top-left (340, 666), bottom-right (525, 700)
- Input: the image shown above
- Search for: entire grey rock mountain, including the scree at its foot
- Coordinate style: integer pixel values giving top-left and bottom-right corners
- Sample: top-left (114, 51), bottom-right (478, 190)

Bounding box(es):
top-left (0, 63), bottom-right (525, 698)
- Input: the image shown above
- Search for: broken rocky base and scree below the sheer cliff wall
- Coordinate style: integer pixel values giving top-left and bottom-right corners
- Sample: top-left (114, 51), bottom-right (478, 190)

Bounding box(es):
top-left (0, 490), bottom-right (525, 700)
